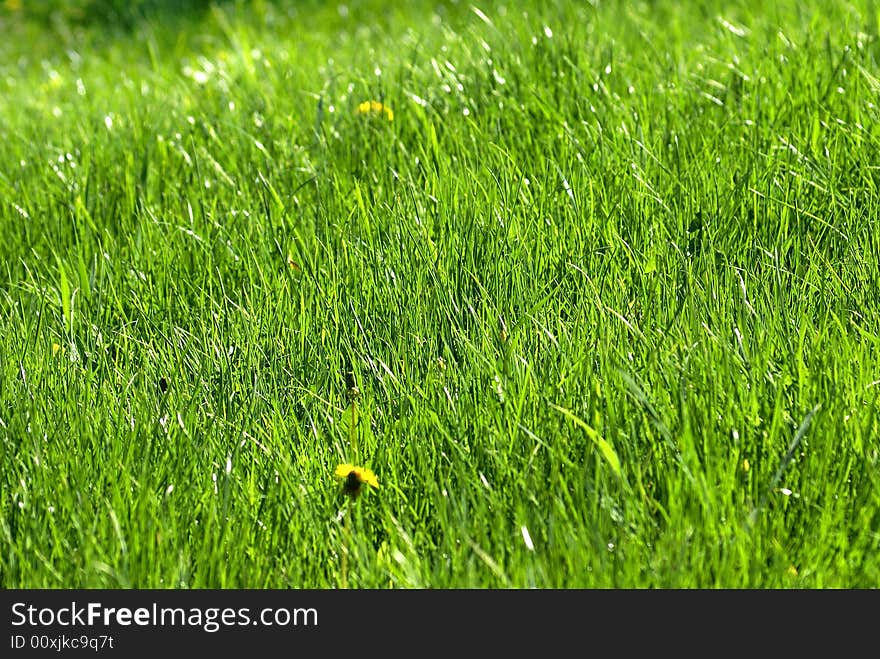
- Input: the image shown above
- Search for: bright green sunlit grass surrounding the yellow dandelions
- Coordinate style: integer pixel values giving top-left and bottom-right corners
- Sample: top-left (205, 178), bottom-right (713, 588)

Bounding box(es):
top-left (0, 0), bottom-right (880, 588)
